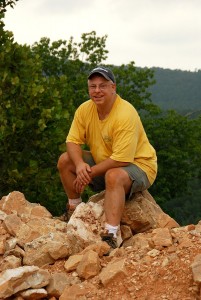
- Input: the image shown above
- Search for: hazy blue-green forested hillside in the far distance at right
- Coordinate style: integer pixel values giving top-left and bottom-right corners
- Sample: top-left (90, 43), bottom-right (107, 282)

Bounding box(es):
top-left (149, 68), bottom-right (201, 115)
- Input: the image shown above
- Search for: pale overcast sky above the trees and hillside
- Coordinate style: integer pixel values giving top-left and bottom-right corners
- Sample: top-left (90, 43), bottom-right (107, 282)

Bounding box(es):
top-left (4, 0), bottom-right (201, 71)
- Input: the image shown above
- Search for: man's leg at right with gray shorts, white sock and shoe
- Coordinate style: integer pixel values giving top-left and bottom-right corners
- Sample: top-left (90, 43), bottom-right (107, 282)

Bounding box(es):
top-left (102, 164), bottom-right (150, 248)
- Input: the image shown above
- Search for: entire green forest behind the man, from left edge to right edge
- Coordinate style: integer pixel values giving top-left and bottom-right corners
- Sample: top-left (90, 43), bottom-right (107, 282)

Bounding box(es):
top-left (0, 0), bottom-right (201, 224)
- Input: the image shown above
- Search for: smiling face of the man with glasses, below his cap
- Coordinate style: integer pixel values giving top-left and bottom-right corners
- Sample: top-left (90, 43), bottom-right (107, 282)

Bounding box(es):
top-left (88, 75), bottom-right (116, 106)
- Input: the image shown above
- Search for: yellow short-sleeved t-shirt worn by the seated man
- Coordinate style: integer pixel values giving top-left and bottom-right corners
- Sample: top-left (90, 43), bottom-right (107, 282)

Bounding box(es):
top-left (66, 95), bottom-right (157, 184)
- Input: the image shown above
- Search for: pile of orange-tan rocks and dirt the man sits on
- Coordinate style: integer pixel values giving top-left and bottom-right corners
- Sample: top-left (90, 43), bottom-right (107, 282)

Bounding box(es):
top-left (0, 191), bottom-right (201, 300)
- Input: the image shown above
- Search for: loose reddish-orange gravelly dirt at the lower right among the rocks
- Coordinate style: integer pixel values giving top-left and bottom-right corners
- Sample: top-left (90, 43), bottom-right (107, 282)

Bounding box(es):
top-left (45, 227), bottom-right (201, 300)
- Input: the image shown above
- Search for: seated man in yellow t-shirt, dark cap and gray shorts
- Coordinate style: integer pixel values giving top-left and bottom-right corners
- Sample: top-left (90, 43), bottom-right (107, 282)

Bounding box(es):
top-left (58, 67), bottom-right (157, 248)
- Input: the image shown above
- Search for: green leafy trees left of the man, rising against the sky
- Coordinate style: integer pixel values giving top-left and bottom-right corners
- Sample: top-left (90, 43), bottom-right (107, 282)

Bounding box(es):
top-left (0, 9), bottom-right (117, 213)
